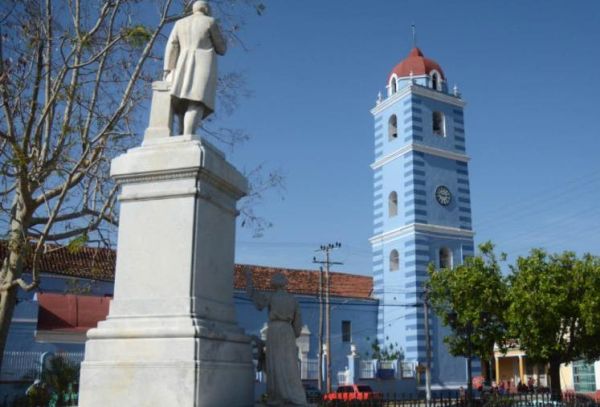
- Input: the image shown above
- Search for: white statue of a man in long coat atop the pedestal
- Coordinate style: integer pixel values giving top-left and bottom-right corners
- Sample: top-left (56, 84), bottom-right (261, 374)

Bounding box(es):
top-left (164, 1), bottom-right (227, 135)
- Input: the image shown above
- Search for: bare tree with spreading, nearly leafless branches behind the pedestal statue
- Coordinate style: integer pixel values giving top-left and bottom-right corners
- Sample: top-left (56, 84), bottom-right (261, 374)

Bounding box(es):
top-left (0, 0), bottom-right (281, 366)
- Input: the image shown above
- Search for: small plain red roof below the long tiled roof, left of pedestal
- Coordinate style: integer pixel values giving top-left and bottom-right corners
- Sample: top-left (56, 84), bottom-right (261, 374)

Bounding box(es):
top-left (37, 293), bottom-right (110, 333)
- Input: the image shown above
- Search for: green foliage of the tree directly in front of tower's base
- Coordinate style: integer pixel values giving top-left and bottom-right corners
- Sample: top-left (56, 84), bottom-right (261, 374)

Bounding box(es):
top-left (427, 242), bottom-right (508, 360)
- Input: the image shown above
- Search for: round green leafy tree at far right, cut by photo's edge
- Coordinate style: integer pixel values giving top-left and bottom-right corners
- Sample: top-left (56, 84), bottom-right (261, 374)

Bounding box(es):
top-left (508, 249), bottom-right (600, 398)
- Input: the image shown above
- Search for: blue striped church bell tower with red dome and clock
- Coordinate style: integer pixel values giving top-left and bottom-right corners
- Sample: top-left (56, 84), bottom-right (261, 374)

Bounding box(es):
top-left (370, 47), bottom-right (473, 389)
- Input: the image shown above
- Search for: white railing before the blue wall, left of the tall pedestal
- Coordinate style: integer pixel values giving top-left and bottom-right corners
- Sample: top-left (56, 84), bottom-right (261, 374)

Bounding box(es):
top-left (0, 351), bottom-right (83, 382)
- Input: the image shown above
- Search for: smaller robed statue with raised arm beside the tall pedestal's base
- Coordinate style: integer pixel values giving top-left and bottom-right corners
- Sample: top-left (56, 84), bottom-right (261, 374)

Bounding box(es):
top-left (246, 269), bottom-right (307, 406)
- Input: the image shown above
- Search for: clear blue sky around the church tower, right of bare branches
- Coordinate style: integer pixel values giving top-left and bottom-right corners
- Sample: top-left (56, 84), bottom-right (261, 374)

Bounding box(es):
top-left (213, 0), bottom-right (600, 274)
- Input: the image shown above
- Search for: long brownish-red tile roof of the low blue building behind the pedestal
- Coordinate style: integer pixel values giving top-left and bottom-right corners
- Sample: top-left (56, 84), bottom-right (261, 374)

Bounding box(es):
top-left (0, 242), bottom-right (373, 299)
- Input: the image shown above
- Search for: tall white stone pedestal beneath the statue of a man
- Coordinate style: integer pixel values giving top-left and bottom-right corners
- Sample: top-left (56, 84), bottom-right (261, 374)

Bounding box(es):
top-left (80, 135), bottom-right (254, 407)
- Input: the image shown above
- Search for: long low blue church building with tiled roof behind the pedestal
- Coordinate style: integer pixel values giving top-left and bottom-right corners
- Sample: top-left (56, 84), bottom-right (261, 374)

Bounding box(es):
top-left (0, 262), bottom-right (378, 404)
